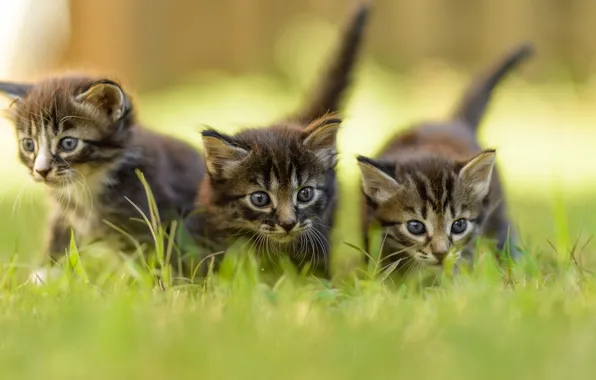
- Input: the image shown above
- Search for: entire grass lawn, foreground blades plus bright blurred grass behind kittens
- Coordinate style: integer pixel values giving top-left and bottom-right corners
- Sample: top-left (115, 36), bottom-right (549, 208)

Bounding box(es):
top-left (0, 64), bottom-right (596, 380)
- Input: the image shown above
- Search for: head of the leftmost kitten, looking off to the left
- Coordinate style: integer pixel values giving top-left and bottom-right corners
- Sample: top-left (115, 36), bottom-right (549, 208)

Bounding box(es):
top-left (0, 77), bottom-right (132, 187)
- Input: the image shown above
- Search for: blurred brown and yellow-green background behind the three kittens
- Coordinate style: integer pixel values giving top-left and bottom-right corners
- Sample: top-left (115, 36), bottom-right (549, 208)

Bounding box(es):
top-left (0, 0), bottom-right (596, 268)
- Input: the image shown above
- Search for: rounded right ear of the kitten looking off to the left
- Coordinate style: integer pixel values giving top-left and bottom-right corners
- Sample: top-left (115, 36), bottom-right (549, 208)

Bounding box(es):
top-left (76, 80), bottom-right (126, 121)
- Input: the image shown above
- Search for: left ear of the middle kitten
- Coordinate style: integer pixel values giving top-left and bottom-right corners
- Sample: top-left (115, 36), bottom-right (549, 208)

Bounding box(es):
top-left (202, 130), bottom-right (249, 178)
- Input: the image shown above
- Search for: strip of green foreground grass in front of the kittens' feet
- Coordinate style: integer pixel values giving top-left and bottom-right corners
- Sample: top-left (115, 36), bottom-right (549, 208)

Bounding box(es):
top-left (0, 242), bottom-right (596, 379)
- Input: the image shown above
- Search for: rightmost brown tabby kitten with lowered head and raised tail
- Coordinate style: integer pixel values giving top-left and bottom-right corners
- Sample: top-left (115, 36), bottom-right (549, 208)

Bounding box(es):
top-left (358, 46), bottom-right (531, 269)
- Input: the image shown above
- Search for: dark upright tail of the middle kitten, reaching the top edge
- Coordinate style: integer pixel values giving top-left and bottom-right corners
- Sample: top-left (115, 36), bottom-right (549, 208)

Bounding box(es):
top-left (291, 0), bottom-right (371, 123)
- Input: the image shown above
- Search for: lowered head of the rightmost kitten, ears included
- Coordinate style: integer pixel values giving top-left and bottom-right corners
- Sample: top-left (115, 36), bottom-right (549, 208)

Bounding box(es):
top-left (358, 150), bottom-right (495, 265)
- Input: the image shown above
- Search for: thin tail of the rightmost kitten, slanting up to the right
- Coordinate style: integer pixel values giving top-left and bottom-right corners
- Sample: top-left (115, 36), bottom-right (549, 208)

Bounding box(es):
top-left (453, 43), bottom-right (534, 130)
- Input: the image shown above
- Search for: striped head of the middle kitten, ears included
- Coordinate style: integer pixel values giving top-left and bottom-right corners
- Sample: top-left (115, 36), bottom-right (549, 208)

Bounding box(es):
top-left (203, 117), bottom-right (340, 243)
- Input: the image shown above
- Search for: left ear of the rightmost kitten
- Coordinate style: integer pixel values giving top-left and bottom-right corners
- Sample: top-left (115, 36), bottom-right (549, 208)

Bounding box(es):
top-left (357, 156), bottom-right (400, 203)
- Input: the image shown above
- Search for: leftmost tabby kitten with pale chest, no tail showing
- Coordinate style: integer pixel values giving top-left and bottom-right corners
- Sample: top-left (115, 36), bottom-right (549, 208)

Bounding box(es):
top-left (0, 76), bottom-right (204, 280)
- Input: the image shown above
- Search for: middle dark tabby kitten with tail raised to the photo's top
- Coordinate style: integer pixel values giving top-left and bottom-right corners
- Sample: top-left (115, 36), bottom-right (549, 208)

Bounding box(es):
top-left (187, 4), bottom-right (369, 275)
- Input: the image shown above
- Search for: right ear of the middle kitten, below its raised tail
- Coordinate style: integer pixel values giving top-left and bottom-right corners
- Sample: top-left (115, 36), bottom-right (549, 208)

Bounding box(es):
top-left (303, 116), bottom-right (341, 168)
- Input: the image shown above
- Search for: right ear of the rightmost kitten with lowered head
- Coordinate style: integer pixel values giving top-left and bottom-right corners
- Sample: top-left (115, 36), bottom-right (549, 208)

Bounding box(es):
top-left (459, 149), bottom-right (496, 199)
